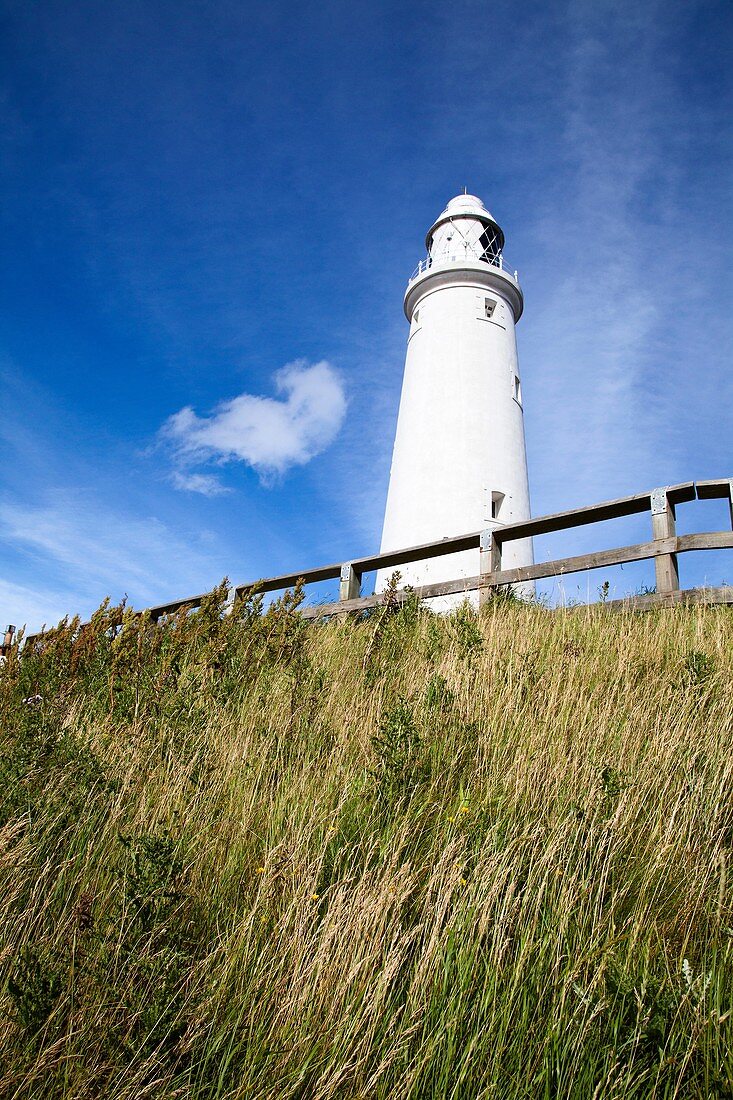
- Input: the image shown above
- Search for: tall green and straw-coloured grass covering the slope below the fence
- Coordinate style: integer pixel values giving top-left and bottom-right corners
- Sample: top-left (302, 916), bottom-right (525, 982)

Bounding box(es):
top-left (0, 590), bottom-right (733, 1100)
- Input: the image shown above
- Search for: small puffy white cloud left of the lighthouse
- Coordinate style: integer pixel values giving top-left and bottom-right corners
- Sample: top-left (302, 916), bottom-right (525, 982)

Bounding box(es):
top-left (162, 360), bottom-right (347, 495)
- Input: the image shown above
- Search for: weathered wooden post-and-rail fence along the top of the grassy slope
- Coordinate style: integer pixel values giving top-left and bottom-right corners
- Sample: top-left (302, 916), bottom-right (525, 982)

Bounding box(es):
top-left (11, 477), bottom-right (733, 641)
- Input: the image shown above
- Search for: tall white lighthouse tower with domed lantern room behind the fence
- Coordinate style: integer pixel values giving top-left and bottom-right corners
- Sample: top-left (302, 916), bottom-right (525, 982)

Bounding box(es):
top-left (376, 195), bottom-right (533, 608)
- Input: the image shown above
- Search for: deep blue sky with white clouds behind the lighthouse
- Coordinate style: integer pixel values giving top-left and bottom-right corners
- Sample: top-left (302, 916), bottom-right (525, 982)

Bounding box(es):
top-left (0, 0), bottom-right (733, 627)
